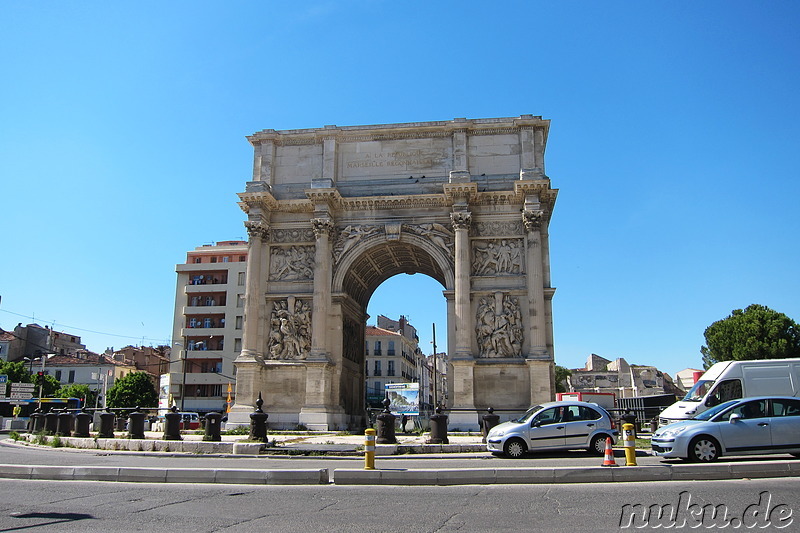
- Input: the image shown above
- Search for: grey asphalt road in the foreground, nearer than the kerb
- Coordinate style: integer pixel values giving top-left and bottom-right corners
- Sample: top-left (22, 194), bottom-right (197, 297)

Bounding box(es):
top-left (0, 478), bottom-right (800, 533)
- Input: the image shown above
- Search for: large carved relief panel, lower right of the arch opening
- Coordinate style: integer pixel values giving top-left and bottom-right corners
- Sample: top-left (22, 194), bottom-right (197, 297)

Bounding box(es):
top-left (475, 292), bottom-right (523, 359)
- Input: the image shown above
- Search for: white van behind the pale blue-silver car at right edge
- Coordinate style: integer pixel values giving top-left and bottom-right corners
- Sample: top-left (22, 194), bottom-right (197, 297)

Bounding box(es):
top-left (658, 359), bottom-right (800, 426)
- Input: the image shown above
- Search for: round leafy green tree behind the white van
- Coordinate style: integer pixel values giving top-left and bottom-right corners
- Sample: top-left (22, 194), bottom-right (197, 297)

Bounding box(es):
top-left (700, 304), bottom-right (800, 368)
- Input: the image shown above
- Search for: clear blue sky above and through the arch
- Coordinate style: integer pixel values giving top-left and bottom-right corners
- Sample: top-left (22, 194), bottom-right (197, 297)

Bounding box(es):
top-left (0, 0), bottom-right (800, 373)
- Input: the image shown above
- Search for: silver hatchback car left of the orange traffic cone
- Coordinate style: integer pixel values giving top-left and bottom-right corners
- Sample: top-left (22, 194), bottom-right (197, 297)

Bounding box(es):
top-left (486, 401), bottom-right (618, 458)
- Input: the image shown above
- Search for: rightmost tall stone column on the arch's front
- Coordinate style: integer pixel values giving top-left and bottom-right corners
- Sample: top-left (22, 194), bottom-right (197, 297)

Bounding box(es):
top-left (522, 206), bottom-right (552, 359)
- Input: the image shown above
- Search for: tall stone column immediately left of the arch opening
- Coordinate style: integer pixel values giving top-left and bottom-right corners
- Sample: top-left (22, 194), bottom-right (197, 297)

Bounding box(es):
top-left (310, 217), bottom-right (333, 360)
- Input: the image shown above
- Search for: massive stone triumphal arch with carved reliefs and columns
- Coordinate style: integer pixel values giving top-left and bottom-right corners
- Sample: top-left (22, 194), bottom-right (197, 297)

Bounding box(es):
top-left (229, 115), bottom-right (557, 429)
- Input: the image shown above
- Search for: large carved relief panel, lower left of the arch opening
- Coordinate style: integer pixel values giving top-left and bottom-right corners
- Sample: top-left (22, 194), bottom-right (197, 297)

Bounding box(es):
top-left (266, 296), bottom-right (311, 360)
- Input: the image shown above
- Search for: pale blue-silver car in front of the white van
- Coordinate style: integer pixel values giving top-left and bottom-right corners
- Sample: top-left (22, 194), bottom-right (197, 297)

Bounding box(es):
top-left (651, 396), bottom-right (800, 462)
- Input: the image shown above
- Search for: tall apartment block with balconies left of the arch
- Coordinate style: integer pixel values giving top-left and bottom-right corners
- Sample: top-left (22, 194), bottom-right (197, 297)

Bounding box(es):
top-left (169, 241), bottom-right (247, 413)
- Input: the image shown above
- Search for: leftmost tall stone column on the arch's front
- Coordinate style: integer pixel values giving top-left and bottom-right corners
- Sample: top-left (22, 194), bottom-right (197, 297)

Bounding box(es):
top-left (237, 220), bottom-right (269, 362)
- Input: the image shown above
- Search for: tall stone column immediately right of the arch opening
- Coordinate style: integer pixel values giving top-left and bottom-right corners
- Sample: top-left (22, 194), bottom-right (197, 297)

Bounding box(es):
top-left (450, 211), bottom-right (472, 359)
